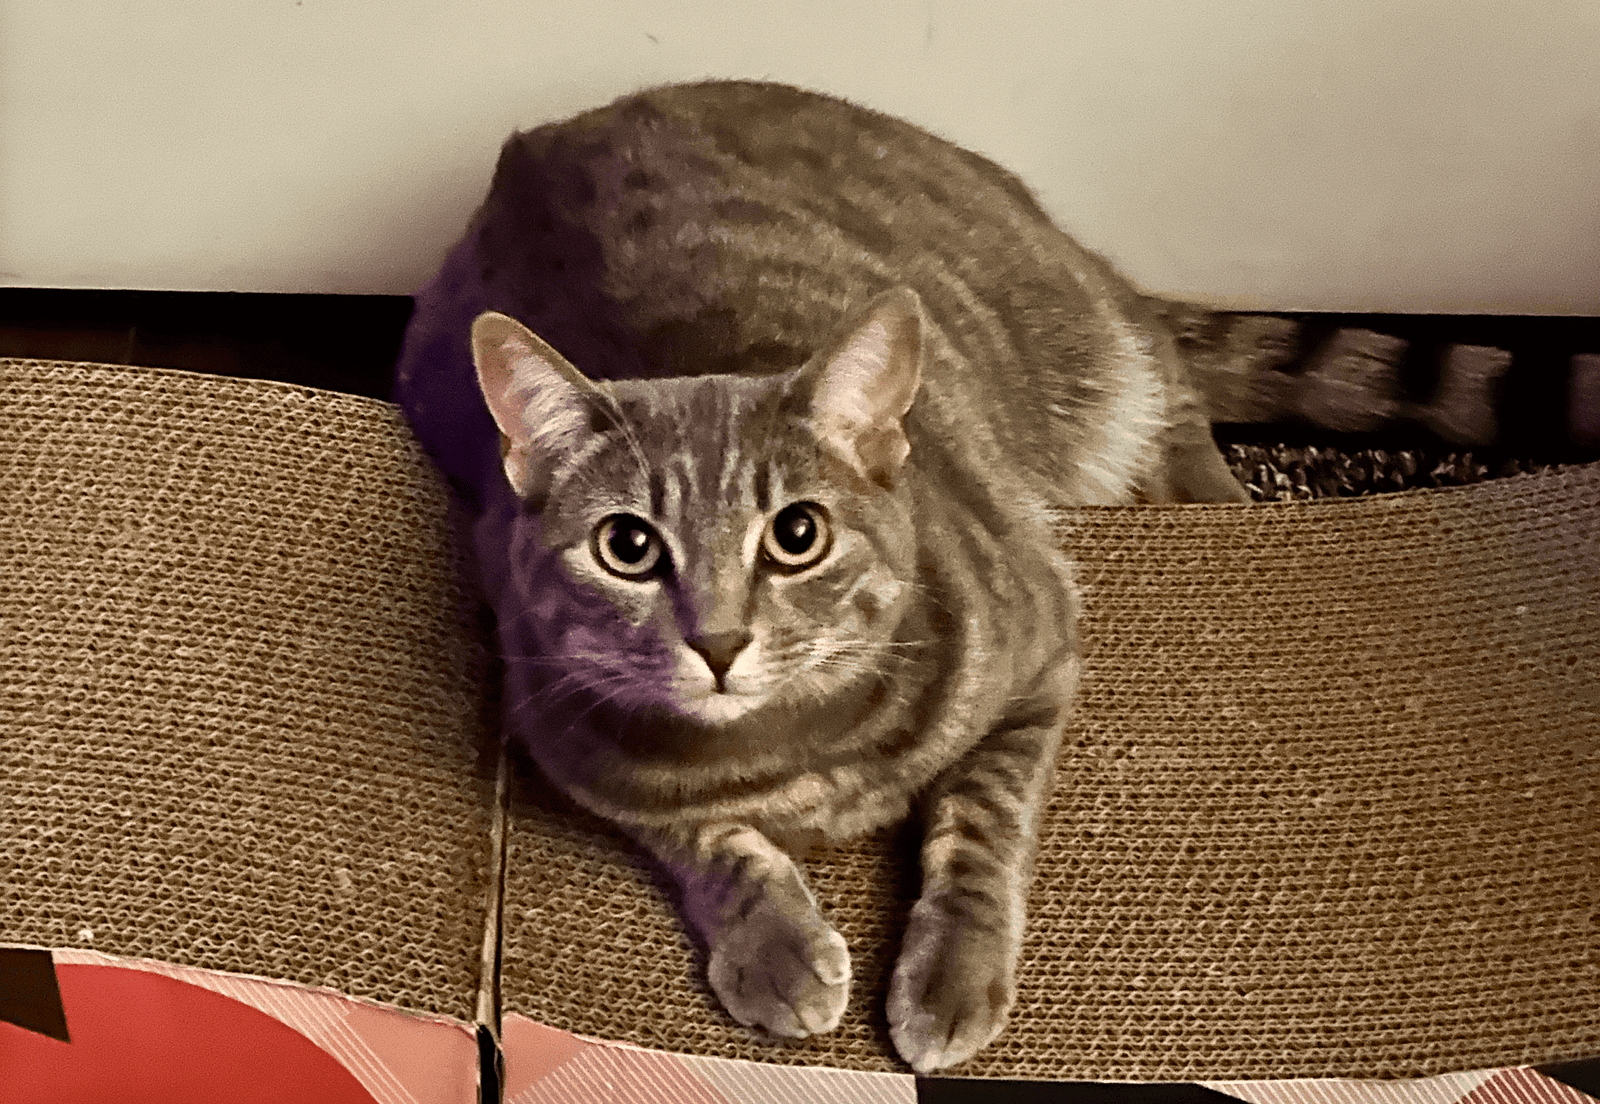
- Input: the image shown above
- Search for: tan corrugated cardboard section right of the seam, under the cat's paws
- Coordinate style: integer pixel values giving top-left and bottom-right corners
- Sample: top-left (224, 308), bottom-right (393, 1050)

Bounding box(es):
top-left (504, 467), bottom-right (1600, 1080)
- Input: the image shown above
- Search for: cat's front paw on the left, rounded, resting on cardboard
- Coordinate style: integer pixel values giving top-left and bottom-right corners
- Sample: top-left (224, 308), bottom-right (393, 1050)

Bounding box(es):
top-left (707, 904), bottom-right (850, 1038)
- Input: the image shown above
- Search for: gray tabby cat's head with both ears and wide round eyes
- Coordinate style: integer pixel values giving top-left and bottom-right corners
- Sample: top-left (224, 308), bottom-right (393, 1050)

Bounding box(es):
top-left (472, 290), bottom-right (923, 726)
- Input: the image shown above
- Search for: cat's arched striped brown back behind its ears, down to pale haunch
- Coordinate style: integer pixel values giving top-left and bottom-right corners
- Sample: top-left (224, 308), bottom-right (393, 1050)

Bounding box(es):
top-left (475, 82), bottom-right (1163, 501)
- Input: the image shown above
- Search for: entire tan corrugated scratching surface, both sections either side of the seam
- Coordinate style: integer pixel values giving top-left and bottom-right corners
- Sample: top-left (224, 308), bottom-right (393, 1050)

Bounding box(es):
top-left (0, 360), bottom-right (1600, 1080)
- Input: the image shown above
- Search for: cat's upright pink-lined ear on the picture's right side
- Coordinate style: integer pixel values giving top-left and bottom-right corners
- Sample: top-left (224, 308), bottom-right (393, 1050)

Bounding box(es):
top-left (790, 288), bottom-right (925, 486)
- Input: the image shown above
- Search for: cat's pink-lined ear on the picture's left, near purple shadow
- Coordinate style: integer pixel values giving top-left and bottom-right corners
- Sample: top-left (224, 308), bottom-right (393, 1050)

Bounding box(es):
top-left (472, 310), bottom-right (595, 501)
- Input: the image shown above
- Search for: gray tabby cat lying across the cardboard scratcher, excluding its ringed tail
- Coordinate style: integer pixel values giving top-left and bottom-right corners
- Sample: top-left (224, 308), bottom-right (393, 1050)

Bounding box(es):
top-left (397, 83), bottom-right (1245, 1070)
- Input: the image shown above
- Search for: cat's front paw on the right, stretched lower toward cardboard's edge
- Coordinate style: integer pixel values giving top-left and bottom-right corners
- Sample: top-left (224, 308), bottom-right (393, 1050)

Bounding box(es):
top-left (888, 898), bottom-right (1016, 1074)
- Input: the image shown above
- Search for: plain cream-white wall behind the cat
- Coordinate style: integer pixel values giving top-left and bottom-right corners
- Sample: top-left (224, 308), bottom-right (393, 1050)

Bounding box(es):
top-left (0, 0), bottom-right (1600, 314)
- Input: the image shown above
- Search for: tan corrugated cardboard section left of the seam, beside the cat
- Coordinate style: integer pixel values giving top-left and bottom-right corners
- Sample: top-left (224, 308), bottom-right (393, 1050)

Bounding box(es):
top-left (0, 360), bottom-right (493, 1019)
